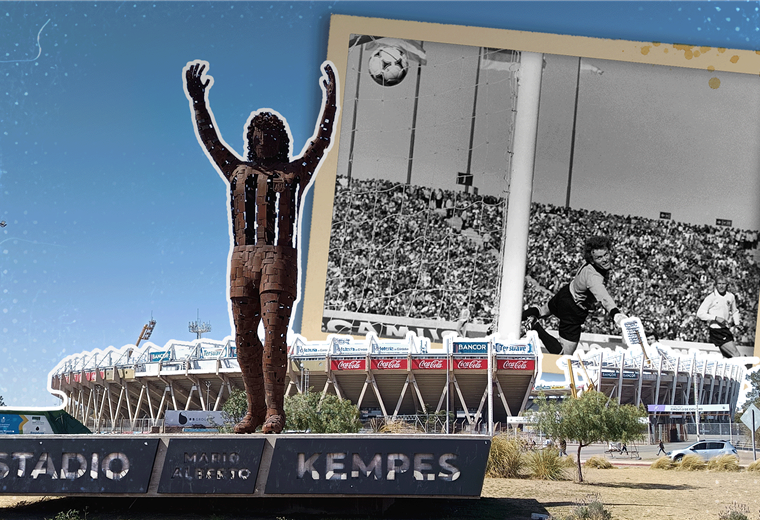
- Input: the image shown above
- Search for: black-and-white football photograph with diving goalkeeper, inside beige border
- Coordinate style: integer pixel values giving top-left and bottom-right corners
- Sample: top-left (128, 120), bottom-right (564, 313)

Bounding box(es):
top-left (306, 22), bottom-right (760, 357)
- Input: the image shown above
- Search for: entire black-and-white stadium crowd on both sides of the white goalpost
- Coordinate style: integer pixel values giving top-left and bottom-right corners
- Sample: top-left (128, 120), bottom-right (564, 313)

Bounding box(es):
top-left (325, 178), bottom-right (760, 345)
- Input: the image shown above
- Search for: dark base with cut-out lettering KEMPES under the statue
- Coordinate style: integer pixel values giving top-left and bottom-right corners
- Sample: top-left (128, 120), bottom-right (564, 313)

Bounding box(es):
top-left (0, 434), bottom-right (491, 503)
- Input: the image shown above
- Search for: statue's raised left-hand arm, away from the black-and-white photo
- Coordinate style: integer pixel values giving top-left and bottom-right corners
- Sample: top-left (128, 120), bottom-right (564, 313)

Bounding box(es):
top-left (185, 60), bottom-right (242, 179)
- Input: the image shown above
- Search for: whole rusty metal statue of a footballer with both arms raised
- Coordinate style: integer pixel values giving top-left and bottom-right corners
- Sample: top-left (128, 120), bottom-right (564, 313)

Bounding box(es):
top-left (184, 61), bottom-right (338, 433)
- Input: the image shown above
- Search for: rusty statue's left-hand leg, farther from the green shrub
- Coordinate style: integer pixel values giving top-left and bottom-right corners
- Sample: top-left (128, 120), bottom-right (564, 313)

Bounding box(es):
top-left (232, 298), bottom-right (266, 433)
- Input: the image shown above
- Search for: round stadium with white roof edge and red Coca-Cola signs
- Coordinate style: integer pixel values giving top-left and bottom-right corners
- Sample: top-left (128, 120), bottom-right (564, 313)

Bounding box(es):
top-left (50, 332), bottom-right (745, 440)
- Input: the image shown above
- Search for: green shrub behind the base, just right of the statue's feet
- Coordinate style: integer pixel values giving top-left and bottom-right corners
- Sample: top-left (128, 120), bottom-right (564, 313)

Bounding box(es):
top-left (285, 392), bottom-right (362, 433)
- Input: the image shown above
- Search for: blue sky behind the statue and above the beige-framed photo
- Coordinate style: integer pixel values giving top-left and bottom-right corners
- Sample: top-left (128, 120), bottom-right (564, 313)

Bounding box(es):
top-left (0, 0), bottom-right (760, 406)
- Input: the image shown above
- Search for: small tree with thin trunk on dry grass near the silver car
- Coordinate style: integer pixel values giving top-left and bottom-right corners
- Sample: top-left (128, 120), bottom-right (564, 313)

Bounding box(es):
top-left (533, 391), bottom-right (647, 482)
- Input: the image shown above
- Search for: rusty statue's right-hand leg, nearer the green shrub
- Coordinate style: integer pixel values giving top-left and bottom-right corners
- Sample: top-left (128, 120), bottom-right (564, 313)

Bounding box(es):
top-left (261, 292), bottom-right (295, 433)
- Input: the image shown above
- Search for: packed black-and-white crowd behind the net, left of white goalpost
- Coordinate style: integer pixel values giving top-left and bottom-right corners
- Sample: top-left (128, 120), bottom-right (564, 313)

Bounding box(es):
top-left (325, 179), bottom-right (504, 323)
